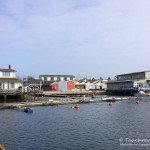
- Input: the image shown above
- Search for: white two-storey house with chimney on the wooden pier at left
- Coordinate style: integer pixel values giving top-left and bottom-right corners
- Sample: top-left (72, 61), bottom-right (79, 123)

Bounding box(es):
top-left (0, 65), bottom-right (21, 90)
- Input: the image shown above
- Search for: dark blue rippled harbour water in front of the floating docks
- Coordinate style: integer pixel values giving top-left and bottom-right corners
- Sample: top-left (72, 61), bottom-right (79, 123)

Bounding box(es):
top-left (0, 99), bottom-right (150, 150)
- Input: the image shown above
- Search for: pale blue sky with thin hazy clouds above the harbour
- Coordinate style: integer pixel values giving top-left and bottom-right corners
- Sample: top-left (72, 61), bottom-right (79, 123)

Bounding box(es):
top-left (0, 0), bottom-right (150, 78)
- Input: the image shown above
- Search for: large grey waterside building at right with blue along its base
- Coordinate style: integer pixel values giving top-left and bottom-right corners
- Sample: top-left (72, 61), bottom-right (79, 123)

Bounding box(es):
top-left (107, 71), bottom-right (150, 95)
